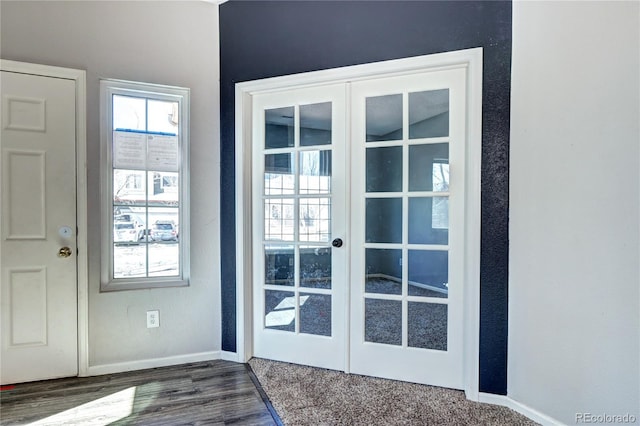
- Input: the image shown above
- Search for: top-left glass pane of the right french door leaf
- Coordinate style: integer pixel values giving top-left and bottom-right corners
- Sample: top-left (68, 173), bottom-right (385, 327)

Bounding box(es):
top-left (366, 94), bottom-right (402, 142)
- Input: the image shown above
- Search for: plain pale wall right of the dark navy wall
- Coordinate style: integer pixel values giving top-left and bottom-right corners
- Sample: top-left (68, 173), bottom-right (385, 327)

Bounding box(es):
top-left (508, 1), bottom-right (640, 424)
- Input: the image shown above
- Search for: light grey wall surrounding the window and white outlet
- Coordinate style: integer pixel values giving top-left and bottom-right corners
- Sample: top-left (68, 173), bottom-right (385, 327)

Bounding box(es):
top-left (0, 0), bottom-right (220, 372)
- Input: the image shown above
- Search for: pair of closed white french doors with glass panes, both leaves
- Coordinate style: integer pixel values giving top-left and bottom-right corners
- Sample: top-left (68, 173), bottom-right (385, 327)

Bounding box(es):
top-left (252, 60), bottom-right (468, 389)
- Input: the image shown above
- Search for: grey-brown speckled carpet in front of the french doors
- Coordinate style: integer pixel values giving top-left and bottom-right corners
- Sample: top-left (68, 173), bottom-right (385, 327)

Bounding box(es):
top-left (249, 358), bottom-right (536, 426)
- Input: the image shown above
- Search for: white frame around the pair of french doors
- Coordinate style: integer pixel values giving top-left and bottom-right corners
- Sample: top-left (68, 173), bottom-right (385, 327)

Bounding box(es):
top-left (234, 48), bottom-right (483, 401)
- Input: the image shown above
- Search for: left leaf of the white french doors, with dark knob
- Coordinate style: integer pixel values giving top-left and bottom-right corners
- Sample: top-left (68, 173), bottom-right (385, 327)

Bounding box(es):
top-left (252, 85), bottom-right (347, 370)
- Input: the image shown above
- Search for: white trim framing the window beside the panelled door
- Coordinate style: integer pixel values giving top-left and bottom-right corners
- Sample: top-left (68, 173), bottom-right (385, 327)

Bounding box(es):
top-left (100, 79), bottom-right (190, 291)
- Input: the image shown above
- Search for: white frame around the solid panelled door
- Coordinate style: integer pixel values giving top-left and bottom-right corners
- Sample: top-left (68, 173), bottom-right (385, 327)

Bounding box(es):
top-left (0, 59), bottom-right (89, 376)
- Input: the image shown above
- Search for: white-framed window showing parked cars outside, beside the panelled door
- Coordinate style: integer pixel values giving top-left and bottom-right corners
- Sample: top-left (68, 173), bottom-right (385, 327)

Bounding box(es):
top-left (100, 80), bottom-right (189, 291)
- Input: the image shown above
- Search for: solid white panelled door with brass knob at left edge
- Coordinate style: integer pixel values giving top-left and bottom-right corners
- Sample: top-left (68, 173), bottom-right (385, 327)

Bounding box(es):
top-left (0, 71), bottom-right (78, 384)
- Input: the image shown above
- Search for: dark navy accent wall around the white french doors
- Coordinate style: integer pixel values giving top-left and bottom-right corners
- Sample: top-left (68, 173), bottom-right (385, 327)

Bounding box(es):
top-left (220, 1), bottom-right (511, 394)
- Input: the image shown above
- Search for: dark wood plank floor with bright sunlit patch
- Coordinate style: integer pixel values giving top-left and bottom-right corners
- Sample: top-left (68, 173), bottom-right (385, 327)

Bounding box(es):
top-left (0, 360), bottom-right (281, 426)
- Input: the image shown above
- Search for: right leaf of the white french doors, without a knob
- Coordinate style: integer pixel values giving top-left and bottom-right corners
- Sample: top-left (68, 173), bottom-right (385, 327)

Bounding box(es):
top-left (349, 69), bottom-right (466, 389)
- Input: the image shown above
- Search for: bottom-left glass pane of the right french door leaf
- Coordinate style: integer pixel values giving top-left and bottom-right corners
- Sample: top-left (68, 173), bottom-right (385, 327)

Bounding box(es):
top-left (364, 298), bottom-right (402, 346)
